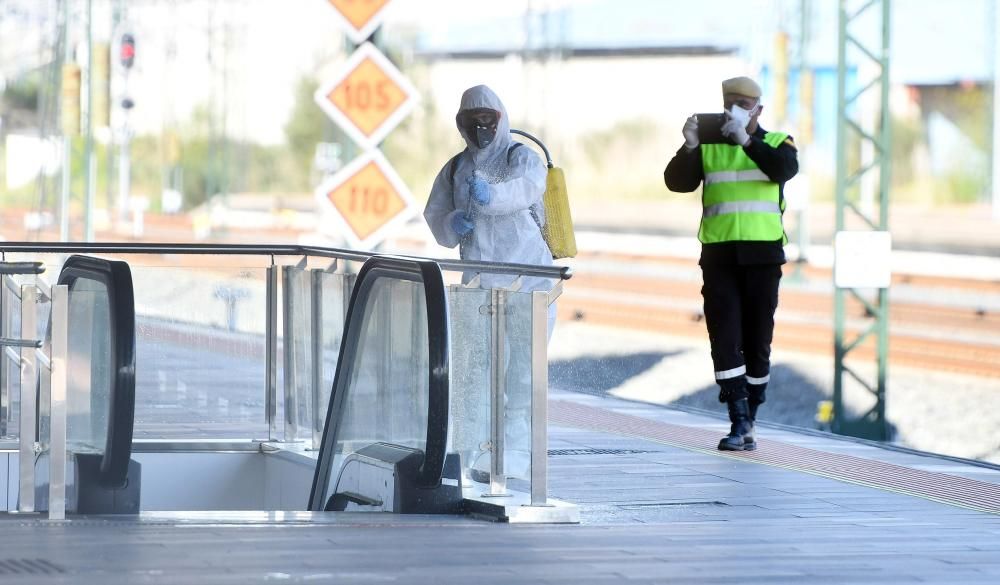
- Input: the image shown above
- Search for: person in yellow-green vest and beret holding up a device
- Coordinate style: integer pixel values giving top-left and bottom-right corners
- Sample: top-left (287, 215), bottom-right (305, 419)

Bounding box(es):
top-left (663, 77), bottom-right (799, 451)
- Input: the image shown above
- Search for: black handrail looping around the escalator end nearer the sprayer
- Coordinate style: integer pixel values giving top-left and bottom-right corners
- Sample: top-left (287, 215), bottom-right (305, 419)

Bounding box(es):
top-left (309, 256), bottom-right (451, 511)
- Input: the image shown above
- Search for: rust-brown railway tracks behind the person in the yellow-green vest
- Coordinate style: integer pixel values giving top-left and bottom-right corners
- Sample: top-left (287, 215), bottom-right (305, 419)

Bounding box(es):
top-left (559, 254), bottom-right (1000, 378)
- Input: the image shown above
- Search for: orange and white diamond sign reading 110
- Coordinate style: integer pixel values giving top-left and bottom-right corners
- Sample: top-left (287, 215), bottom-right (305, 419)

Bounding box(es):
top-left (316, 151), bottom-right (414, 248)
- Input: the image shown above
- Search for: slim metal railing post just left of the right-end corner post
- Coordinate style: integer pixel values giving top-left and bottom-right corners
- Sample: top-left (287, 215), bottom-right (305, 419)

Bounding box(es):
top-left (488, 288), bottom-right (507, 496)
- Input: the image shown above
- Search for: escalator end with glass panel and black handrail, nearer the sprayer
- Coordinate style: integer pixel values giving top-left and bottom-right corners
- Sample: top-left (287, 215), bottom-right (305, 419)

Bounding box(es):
top-left (309, 256), bottom-right (462, 513)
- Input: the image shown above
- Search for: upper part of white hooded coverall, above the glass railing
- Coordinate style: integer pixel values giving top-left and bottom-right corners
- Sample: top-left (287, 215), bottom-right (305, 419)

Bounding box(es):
top-left (424, 85), bottom-right (555, 334)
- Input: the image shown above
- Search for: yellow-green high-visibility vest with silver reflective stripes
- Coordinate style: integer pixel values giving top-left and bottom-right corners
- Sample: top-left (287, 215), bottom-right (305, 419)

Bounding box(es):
top-left (698, 132), bottom-right (788, 244)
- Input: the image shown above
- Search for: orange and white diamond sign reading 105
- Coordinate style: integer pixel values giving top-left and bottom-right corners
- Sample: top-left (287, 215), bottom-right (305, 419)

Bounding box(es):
top-left (314, 43), bottom-right (417, 148)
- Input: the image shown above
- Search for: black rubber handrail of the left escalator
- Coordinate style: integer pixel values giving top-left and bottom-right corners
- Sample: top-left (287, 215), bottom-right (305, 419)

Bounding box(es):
top-left (58, 255), bottom-right (136, 489)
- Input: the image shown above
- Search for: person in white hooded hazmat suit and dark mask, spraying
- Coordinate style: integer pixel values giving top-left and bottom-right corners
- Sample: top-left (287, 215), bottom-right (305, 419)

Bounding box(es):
top-left (424, 85), bottom-right (555, 480)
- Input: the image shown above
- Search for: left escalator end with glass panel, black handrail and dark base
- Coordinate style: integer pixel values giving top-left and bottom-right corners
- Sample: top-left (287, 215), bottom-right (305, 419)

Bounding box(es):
top-left (36, 255), bottom-right (141, 514)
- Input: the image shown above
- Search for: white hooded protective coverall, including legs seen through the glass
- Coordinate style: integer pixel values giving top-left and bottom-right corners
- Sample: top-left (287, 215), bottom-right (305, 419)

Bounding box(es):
top-left (424, 85), bottom-right (556, 478)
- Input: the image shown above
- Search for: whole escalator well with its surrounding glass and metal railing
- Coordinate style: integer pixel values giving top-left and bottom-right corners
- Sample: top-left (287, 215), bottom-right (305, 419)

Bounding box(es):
top-left (0, 244), bottom-right (572, 522)
